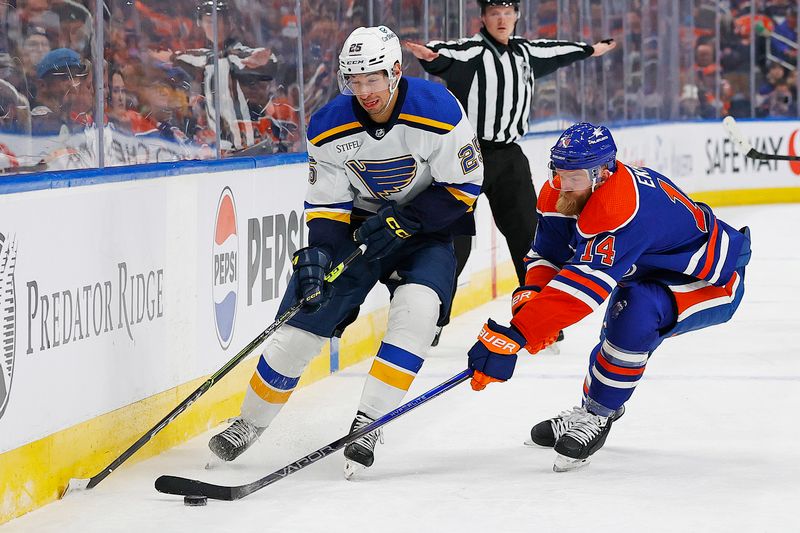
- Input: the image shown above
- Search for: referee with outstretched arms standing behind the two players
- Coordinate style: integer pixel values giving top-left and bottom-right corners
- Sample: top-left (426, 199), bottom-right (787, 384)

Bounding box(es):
top-left (406, 0), bottom-right (616, 344)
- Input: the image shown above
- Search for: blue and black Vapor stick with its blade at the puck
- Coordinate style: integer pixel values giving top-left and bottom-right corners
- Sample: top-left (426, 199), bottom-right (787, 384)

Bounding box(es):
top-left (155, 369), bottom-right (472, 501)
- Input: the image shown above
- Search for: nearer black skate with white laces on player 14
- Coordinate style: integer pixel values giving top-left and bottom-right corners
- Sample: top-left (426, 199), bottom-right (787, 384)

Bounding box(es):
top-left (553, 409), bottom-right (615, 472)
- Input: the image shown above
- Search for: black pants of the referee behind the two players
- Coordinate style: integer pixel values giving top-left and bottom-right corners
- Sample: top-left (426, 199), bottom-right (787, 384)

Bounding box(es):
top-left (440, 141), bottom-right (536, 325)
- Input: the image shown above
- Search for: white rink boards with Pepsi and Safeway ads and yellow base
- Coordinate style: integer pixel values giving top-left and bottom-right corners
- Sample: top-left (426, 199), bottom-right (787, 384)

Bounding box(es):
top-left (0, 121), bottom-right (800, 523)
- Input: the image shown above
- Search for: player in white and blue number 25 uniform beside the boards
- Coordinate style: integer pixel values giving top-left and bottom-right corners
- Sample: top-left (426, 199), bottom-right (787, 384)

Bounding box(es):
top-left (209, 26), bottom-right (483, 477)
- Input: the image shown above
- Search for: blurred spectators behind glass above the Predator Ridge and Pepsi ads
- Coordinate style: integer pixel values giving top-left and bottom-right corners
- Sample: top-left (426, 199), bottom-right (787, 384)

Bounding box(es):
top-left (0, 0), bottom-right (302, 171)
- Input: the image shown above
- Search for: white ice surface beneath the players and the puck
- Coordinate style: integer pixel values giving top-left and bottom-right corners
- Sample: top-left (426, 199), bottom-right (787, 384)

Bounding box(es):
top-left (0, 205), bottom-right (800, 533)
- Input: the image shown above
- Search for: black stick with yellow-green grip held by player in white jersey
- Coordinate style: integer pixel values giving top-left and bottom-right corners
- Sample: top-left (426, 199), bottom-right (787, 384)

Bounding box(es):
top-left (62, 244), bottom-right (367, 498)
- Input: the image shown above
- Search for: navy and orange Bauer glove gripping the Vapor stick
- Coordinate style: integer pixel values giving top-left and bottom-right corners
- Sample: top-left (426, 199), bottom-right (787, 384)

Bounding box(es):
top-left (469, 318), bottom-right (527, 390)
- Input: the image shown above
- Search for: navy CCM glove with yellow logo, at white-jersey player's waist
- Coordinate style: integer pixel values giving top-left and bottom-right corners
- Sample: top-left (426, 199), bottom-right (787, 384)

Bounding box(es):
top-left (353, 202), bottom-right (422, 261)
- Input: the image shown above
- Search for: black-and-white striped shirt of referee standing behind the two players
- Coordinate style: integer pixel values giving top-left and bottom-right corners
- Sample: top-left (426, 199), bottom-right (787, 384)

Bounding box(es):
top-left (420, 28), bottom-right (594, 143)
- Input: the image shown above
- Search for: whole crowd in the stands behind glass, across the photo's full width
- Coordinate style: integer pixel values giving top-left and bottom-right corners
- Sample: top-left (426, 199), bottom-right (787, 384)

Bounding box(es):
top-left (0, 0), bottom-right (798, 172)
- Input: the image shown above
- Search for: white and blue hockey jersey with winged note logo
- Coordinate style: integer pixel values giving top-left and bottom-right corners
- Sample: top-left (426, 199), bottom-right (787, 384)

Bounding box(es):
top-left (305, 77), bottom-right (483, 249)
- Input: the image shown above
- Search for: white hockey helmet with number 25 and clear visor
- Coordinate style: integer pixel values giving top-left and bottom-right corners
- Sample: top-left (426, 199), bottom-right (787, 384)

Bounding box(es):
top-left (338, 26), bottom-right (403, 95)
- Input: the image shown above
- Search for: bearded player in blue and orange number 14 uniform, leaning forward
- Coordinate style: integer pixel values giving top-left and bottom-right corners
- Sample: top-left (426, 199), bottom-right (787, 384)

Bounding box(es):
top-left (462, 123), bottom-right (750, 471)
